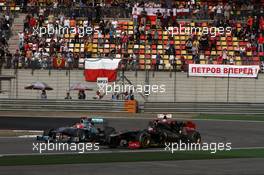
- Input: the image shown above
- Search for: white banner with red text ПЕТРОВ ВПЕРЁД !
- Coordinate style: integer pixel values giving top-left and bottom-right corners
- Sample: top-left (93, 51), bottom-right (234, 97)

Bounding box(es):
top-left (188, 64), bottom-right (260, 78)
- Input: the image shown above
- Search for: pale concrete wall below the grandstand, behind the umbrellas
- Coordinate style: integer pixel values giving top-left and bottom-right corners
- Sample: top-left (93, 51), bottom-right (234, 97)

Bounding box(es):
top-left (0, 70), bottom-right (264, 102)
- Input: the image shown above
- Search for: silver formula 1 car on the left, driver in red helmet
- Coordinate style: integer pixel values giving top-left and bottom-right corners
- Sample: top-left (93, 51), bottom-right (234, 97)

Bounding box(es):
top-left (37, 117), bottom-right (115, 144)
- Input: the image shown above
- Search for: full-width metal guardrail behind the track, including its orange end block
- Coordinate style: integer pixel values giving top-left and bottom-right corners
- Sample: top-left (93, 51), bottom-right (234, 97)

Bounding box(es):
top-left (0, 99), bottom-right (264, 114)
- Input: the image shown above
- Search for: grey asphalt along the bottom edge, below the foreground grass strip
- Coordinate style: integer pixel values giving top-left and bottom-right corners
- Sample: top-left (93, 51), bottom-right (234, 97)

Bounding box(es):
top-left (0, 159), bottom-right (264, 175)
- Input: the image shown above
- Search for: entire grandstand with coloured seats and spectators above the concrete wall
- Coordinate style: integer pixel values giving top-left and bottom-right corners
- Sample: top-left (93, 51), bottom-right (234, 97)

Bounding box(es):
top-left (0, 0), bottom-right (264, 100)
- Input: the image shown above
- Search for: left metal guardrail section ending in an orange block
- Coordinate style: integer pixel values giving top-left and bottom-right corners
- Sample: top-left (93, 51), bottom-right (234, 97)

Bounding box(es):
top-left (0, 99), bottom-right (137, 113)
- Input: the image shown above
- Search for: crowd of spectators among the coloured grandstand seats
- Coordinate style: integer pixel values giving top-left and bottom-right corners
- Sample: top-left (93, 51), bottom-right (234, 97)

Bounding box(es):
top-left (0, 0), bottom-right (264, 70)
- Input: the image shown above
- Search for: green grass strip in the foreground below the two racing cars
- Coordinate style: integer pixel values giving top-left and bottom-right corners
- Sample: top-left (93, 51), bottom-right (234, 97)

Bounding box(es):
top-left (0, 148), bottom-right (264, 166)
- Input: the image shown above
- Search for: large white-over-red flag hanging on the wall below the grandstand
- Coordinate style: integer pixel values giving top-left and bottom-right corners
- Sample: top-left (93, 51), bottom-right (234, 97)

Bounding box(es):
top-left (84, 58), bottom-right (120, 82)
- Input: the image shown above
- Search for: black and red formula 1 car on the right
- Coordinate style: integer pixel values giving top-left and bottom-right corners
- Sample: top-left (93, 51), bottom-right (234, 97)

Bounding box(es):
top-left (108, 115), bottom-right (201, 149)
